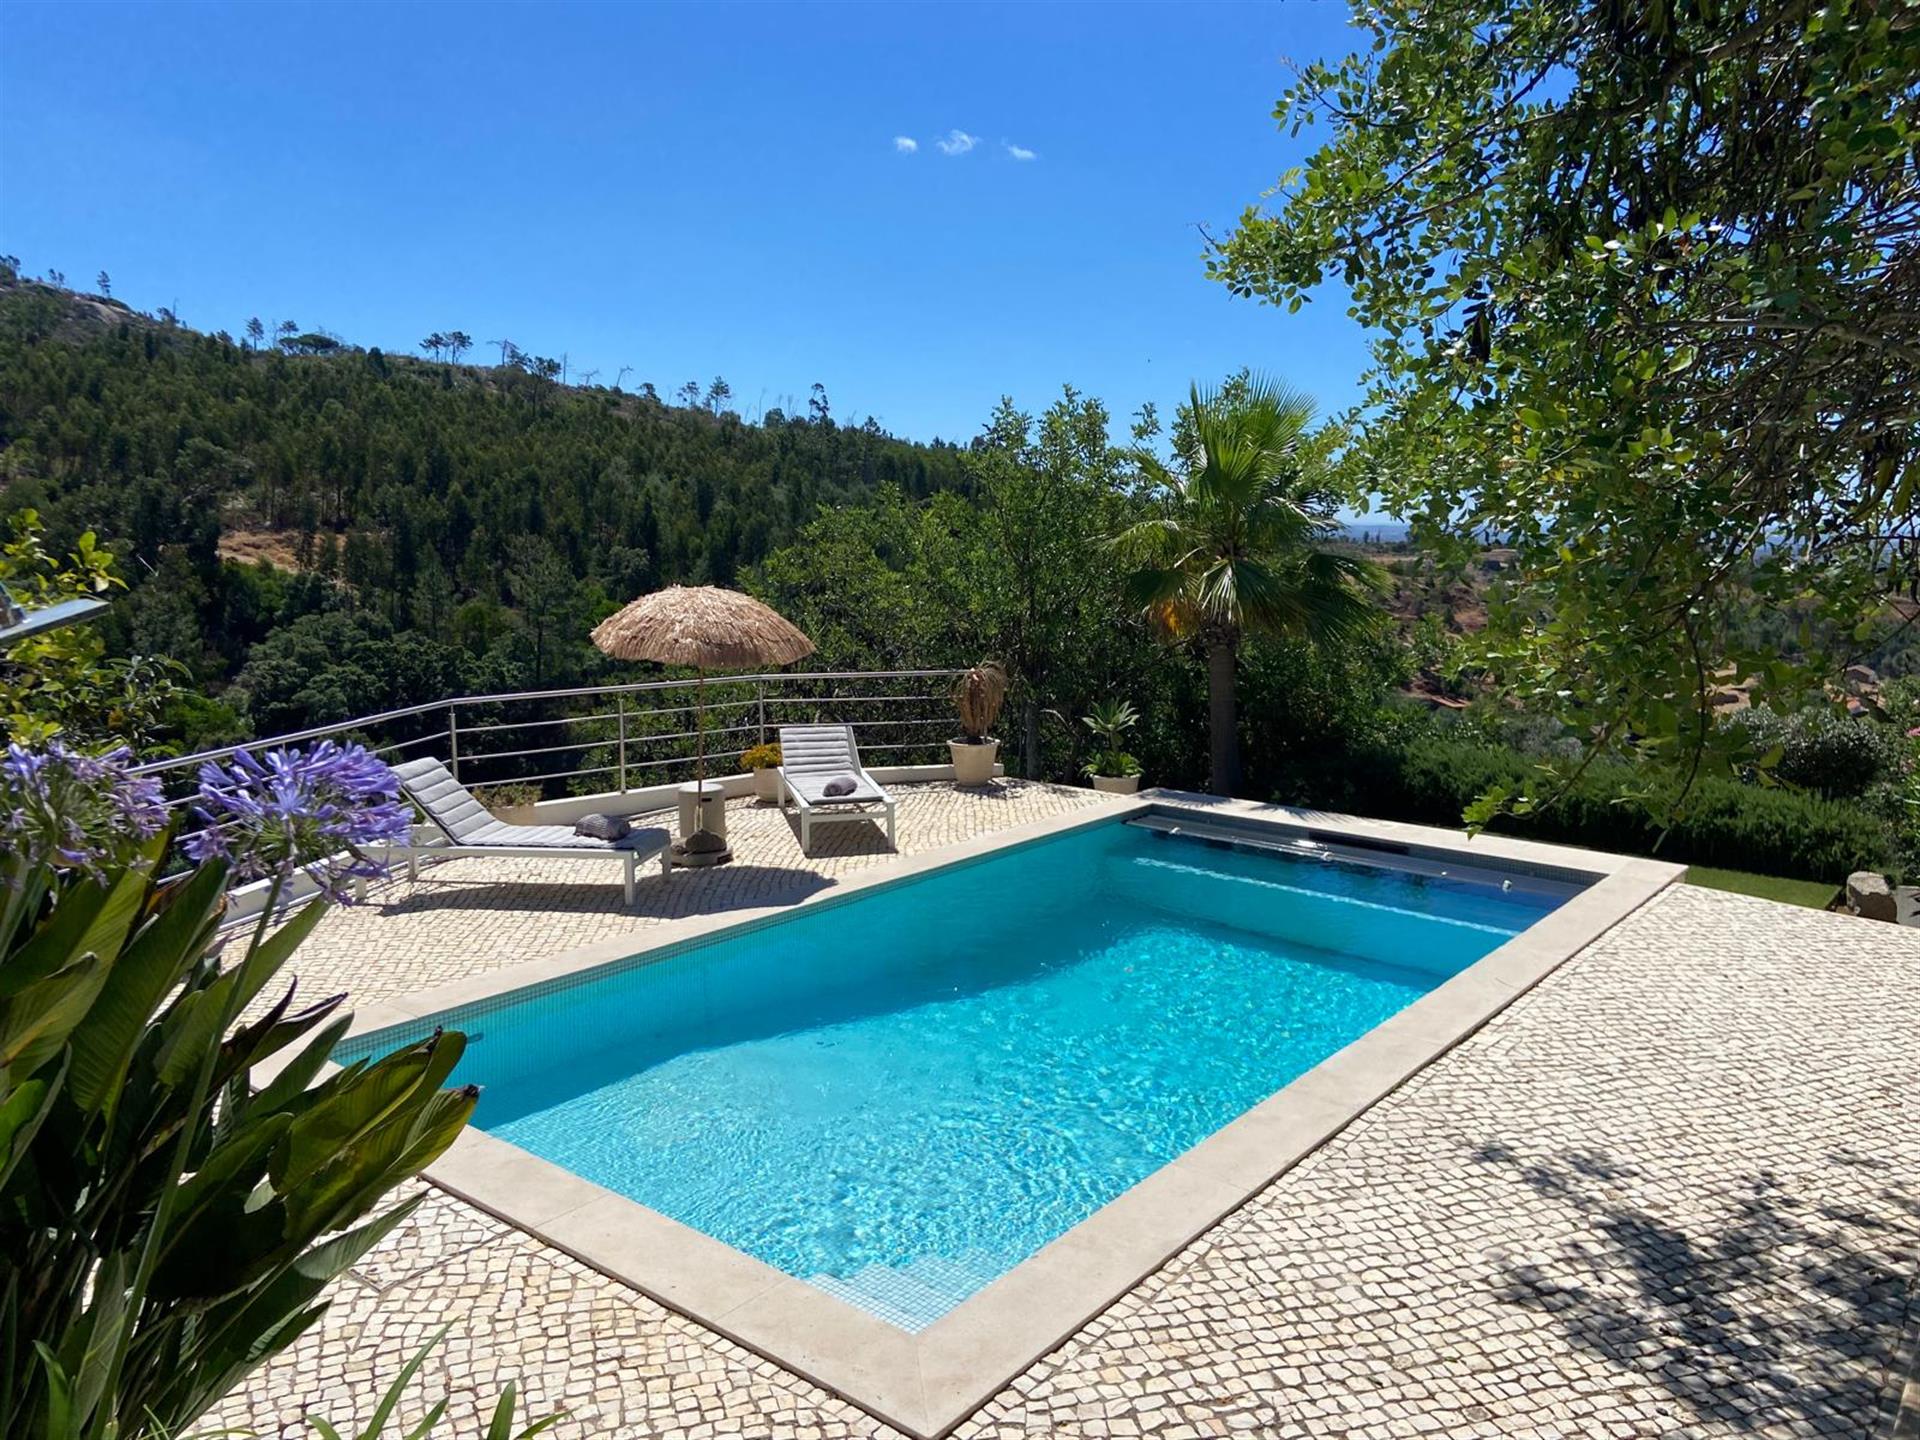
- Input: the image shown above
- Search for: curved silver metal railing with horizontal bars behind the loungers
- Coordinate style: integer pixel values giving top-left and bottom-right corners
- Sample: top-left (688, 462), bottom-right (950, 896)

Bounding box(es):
top-left (134, 670), bottom-right (962, 801)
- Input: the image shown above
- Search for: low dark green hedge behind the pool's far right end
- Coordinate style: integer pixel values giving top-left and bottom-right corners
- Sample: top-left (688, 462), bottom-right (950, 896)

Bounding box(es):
top-left (1275, 739), bottom-right (1893, 883)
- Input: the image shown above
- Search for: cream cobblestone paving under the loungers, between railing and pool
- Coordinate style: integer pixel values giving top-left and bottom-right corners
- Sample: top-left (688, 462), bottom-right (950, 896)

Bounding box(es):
top-left (270, 780), bottom-right (1108, 1004)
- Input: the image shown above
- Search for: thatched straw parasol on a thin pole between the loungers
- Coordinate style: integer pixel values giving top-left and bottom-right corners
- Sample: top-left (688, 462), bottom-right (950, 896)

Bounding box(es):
top-left (593, 586), bottom-right (814, 849)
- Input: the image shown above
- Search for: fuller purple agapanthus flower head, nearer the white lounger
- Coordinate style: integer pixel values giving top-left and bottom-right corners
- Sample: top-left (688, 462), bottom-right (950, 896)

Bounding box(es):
top-left (180, 739), bottom-right (413, 902)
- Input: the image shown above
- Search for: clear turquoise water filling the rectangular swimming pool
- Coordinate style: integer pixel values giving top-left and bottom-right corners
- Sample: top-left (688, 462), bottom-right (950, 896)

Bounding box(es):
top-left (349, 824), bottom-right (1555, 1329)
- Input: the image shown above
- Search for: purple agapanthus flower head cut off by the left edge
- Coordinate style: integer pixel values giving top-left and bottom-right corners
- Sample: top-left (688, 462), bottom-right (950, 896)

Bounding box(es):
top-left (0, 739), bottom-right (167, 879)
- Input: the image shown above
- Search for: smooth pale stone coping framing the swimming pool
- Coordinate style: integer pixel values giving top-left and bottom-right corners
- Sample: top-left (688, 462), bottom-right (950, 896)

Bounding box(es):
top-left (291, 791), bottom-right (1686, 1440)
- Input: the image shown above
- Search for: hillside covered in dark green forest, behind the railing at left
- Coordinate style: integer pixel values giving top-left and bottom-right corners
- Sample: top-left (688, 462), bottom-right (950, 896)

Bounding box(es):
top-left (0, 280), bottom-right (964, 744)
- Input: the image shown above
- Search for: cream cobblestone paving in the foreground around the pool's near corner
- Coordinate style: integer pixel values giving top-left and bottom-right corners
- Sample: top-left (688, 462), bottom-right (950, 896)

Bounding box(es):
top-left (219, 887), bottom-right (1920, 1440)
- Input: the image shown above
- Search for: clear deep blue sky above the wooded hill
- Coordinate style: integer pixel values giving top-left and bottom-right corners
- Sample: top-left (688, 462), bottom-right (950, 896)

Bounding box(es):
top-left (0, 0), bottom-right (1365, 438)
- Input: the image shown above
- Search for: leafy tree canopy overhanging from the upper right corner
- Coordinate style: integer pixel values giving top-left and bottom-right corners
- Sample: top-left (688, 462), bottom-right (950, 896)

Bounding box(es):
top-left (1210, 0), bottom-right (1920, 802)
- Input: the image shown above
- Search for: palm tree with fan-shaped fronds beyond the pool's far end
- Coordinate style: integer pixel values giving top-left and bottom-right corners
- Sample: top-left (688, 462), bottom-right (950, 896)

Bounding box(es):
top-left (1114, 376), bottom-right (1379, 795)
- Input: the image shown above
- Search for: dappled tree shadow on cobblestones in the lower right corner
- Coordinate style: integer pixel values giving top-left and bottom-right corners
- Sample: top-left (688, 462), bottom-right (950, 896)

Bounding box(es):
top-left (1475, 1144), bottom-right (1920, 1440)
